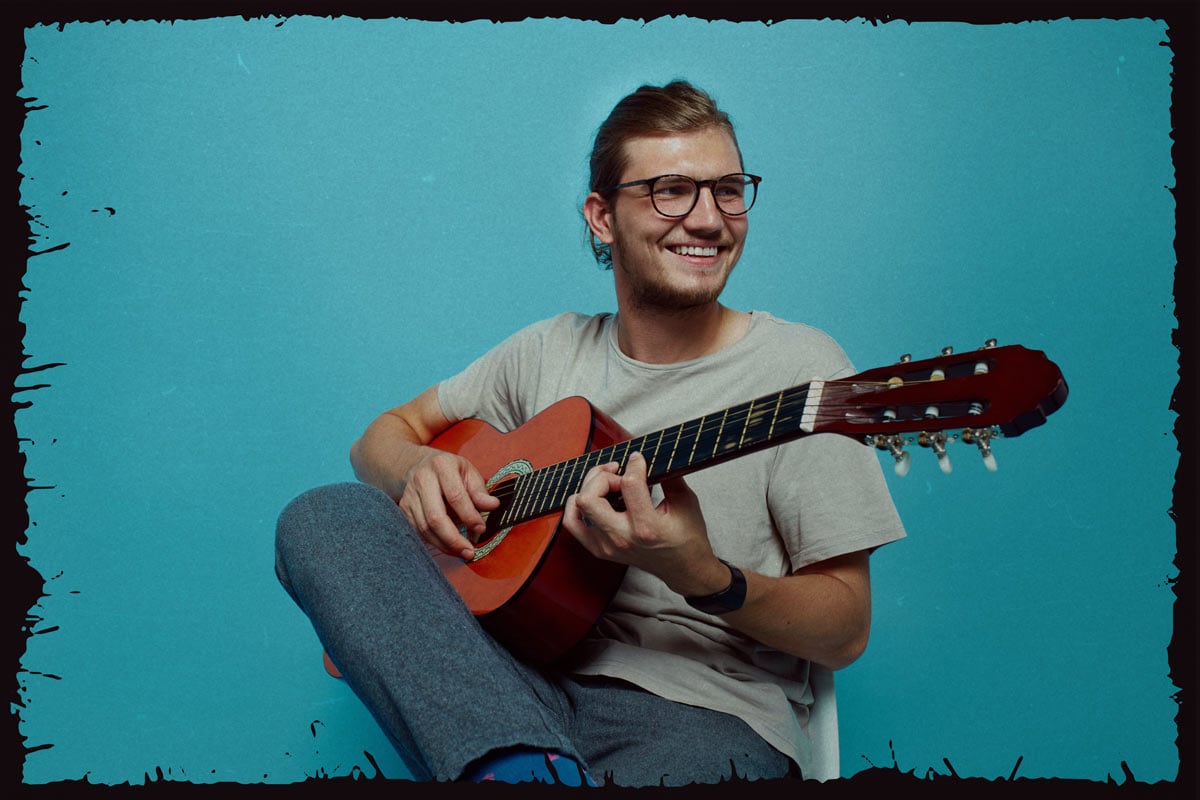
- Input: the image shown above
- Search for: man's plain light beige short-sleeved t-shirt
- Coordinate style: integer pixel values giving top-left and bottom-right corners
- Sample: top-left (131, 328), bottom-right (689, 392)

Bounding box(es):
top-left (438, 312), bottom-right (905, 770)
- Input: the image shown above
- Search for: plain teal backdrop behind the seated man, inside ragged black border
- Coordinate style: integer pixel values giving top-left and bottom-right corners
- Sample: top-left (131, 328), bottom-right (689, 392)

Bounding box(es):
top-left (17, 17), bottom-right (1180, 783)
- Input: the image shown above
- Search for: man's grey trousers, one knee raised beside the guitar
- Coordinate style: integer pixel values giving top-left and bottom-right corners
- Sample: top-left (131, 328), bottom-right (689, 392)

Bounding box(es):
top-left (276, 483), bottom-right (796, 786)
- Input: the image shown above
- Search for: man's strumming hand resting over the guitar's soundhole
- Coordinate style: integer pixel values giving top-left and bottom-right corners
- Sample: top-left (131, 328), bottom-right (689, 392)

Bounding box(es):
top-left (400, 447), bottom-right (500, 560)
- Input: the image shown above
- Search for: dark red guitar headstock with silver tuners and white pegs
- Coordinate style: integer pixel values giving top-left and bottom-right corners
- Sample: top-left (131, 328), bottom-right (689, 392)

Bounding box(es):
top-left (814, 339), bottom-right (1067, 475)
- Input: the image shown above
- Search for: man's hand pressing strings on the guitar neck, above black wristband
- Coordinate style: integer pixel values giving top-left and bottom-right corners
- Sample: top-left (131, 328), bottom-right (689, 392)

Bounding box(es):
top-left (563, 452), bottom-right (730, 595)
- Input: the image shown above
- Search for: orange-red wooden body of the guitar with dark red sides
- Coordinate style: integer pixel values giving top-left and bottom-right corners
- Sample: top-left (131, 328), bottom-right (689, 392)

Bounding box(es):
top-left (431, 397), bottom-right (629, 663)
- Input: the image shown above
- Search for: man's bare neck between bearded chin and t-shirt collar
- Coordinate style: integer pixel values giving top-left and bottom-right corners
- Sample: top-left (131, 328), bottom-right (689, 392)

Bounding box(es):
top-left (617, 302), bottom-right (750, 363)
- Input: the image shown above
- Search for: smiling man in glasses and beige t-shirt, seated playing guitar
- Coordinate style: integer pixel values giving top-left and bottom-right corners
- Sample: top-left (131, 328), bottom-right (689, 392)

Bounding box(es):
top-left (277, 82), bottom-right (904, 786)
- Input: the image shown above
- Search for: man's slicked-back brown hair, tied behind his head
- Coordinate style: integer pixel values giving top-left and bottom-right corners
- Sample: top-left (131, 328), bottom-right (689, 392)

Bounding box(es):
top-left (588, 80), bottom-right (742, 266)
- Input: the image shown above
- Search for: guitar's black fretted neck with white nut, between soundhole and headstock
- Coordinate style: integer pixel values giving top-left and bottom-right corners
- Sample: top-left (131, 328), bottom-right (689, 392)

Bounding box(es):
top-left (502, 381), bottom-right (823, 525)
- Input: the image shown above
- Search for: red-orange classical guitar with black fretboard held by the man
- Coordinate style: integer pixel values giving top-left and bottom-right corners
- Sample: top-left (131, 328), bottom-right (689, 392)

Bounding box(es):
top-left (325, 341), bottom-right (1067, 674)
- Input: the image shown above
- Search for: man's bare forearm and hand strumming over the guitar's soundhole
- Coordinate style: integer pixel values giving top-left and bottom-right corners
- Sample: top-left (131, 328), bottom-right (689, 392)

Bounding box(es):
top-left (350, 386), bottom-right (499, 558)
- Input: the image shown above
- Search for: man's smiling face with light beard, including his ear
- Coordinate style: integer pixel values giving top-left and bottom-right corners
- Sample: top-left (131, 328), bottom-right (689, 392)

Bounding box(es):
top-left (598, 127), bottom-right (748, 311)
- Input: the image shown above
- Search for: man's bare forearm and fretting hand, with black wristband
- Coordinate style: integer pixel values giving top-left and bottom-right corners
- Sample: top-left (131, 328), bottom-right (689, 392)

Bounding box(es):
top-left (563, 455), bottom-right (871, 669)
